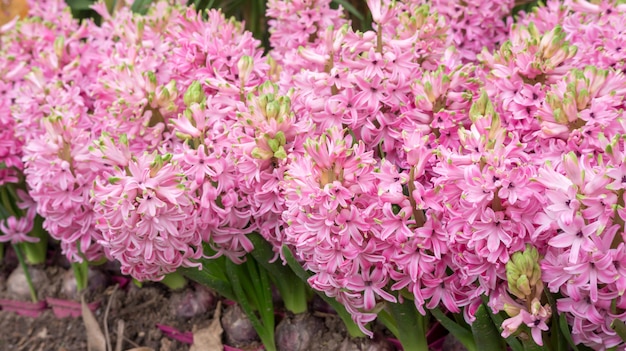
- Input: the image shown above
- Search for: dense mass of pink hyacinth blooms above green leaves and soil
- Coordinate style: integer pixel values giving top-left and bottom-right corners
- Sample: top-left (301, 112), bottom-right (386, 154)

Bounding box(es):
top-left (0, 0), bottom-right (626, 350)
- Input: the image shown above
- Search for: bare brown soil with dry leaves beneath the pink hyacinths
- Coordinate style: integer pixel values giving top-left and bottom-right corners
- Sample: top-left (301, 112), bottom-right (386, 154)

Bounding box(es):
top-left (0, 250), bottom-right (463, 351)
